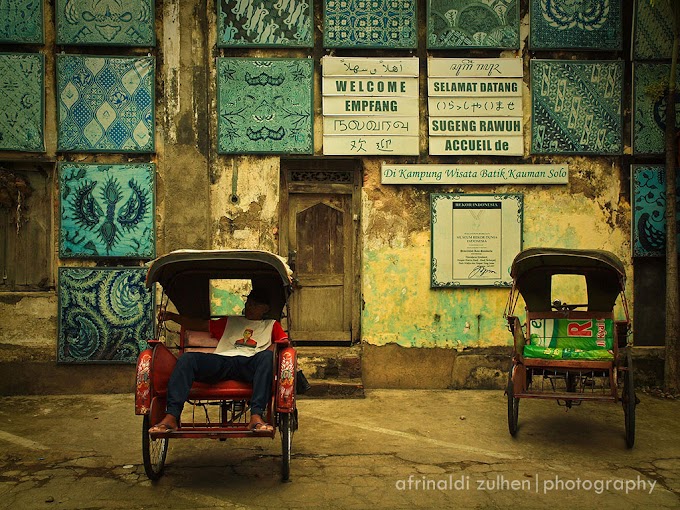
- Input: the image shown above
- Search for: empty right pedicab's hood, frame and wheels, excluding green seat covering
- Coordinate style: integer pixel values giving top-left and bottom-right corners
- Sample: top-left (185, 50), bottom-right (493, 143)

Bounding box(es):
top-left (504, 248), bottom-right (638, 448)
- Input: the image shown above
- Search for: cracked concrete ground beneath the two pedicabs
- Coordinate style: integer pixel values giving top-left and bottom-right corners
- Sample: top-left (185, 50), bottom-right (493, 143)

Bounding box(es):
top-left (0, 390), bottom-right (680, 510)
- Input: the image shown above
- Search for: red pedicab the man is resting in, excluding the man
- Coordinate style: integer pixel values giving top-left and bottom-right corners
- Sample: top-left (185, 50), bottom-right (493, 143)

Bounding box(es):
top-left (135, 250), bottom-right (298, 481)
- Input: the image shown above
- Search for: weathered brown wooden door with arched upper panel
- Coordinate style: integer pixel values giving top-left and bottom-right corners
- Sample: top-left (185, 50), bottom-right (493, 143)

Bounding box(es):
top-left (282, 163), bottom-right (359, 343)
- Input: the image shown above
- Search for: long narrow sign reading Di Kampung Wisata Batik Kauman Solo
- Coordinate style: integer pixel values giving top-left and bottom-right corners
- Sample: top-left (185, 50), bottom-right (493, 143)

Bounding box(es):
top-left (381, 164), bottom-right (569, 184)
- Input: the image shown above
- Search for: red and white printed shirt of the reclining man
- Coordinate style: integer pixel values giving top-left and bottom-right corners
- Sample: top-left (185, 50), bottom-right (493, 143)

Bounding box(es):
top-left (210, 316), bottom-right (288, 356)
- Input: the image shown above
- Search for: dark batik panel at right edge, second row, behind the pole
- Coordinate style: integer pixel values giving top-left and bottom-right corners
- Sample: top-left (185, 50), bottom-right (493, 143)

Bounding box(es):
top-left (633, 62), bottom-right (680, 154)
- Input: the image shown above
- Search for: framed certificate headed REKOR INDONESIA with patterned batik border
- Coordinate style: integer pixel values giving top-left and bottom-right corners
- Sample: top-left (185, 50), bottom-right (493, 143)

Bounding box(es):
top-left (430, 193), bottom-right (524, 288)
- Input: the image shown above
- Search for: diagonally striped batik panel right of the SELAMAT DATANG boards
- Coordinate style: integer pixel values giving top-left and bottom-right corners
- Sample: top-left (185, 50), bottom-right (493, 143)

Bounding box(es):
top-left (531, 60), bottom-right (623, 155)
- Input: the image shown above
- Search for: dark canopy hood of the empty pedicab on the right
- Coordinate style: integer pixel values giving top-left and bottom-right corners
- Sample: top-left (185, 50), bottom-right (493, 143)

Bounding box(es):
top-left (510, 248), bottom-right (626, 312)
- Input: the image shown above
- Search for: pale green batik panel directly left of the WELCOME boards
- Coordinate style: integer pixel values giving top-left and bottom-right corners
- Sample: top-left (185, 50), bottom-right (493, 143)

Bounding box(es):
top-left (217, 58), bottom-right (314, 154)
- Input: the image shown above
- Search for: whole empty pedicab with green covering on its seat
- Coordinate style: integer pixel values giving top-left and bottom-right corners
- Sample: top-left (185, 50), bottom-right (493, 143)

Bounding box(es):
top-left (504, 248), bottom-right (638, 448)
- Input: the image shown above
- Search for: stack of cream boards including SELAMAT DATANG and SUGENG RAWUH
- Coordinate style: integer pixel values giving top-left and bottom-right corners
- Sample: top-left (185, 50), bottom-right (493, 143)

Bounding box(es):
top-left (427, 58), bottom-right (524, 156)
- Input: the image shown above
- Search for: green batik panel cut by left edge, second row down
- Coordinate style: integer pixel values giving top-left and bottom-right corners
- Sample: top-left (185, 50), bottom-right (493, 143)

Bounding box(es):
top-left (0, 53), bottom-right (45, 152)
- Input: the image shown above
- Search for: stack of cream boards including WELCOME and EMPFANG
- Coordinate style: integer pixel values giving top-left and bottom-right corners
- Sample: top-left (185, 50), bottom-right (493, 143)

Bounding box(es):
top-left (321, 57), bottom-right (420, 156)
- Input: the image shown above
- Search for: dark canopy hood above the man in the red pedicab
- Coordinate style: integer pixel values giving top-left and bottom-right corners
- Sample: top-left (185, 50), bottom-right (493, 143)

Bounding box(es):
top-left (146, 250), bottom-right (292, 320)
